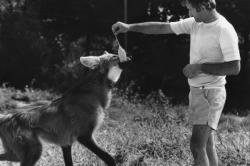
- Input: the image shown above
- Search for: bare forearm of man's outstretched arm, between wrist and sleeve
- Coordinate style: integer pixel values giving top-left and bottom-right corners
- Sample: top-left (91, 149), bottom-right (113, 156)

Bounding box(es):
top-left (129, 22), bottom-right (173, 34)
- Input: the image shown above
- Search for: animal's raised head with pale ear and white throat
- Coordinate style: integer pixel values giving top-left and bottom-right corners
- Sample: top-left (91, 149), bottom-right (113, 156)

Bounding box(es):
top-left (80, 51), bottom-right (127, 82)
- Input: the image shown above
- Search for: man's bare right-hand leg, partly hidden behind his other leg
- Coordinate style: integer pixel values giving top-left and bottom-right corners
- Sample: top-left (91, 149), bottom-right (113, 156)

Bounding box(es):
top-left (207, 131), bottom-right (219, 166)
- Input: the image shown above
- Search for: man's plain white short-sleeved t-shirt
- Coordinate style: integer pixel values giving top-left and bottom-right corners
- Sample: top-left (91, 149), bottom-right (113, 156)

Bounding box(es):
top-left (170, 16), bottom-right (240, 87)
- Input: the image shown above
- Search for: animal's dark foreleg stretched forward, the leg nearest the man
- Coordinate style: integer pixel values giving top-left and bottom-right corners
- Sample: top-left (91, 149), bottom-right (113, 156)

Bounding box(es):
top-left (78, 136), bottom-right (116, 166)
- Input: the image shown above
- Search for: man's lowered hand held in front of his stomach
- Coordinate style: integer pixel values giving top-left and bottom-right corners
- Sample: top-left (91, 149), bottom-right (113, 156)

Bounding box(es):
top-left (183, 64), bottom-right (202, 78)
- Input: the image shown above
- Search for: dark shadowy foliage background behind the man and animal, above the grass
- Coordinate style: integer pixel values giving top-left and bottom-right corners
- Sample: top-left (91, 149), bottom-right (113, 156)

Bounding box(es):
top-left (0, 0), bottom-right (250, 113)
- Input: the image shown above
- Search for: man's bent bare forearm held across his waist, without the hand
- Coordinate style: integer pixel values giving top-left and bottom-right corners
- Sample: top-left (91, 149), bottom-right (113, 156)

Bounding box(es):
top-left (200, 60), bottom-right (240, 76)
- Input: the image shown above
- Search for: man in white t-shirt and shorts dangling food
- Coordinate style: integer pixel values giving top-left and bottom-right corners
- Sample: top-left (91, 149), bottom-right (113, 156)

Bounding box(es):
top-left (112, 0), bottom-right (240, 166)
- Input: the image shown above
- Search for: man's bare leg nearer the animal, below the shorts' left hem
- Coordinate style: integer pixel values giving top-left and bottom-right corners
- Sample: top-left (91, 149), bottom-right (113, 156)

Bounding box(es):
top-left (190, 125), bottom-right (212, 166)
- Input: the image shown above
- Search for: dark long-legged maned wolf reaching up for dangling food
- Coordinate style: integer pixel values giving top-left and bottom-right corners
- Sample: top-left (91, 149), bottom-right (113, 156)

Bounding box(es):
top-left (0, 52), bottom-right (127, 166)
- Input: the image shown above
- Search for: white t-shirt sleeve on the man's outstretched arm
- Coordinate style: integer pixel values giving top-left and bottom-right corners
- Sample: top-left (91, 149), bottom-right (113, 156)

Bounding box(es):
top-left (170, 17), bottom-right (195, 35)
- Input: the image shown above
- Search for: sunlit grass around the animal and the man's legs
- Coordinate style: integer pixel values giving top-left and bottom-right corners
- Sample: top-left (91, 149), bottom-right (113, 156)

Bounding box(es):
top-left (0, 86), bottom-right (250, 166)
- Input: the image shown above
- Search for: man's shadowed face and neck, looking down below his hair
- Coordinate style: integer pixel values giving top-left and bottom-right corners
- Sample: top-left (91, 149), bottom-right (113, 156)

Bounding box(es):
top-left (186, 1), bottom-right (205, 22)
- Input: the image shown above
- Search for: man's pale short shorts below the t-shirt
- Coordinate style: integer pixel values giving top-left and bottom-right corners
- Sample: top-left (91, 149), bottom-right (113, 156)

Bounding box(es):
top-left (189, 86), bottom-right (226, 130)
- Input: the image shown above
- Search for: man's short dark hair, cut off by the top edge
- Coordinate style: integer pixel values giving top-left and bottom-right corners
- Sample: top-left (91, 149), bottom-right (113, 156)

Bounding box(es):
top-left (187, 0), bottom-right (216, 11)
